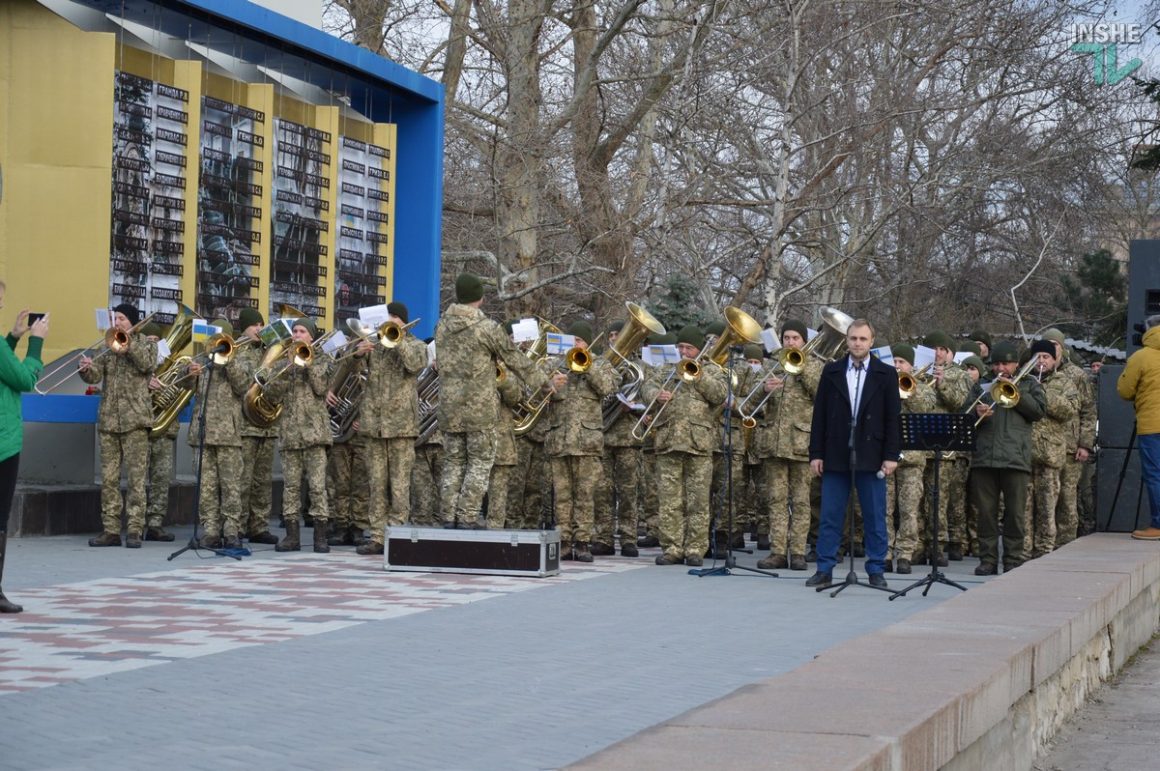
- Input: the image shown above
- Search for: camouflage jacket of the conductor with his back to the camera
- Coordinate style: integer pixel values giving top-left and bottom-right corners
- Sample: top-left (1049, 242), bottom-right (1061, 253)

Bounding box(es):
top-left (435, 303), bottom-right (548, 432)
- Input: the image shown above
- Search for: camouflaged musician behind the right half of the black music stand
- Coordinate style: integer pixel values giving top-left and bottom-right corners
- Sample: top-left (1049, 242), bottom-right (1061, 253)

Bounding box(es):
top-left (912, 332), bottom-right (971, 566)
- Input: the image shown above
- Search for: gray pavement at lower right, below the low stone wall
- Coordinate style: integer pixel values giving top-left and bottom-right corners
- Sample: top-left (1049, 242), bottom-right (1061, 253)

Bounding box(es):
top-left (1035, 638), bottom-right (1160, 771)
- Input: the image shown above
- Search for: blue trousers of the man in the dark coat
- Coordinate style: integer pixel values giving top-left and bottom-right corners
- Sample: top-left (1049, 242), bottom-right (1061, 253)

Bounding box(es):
top-left (818, 466), bottom-right (886, 575)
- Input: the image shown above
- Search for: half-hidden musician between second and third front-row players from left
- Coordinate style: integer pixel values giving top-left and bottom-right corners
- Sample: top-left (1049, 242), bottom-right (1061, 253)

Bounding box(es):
top-left (234, 308), bottom-right (278, 544)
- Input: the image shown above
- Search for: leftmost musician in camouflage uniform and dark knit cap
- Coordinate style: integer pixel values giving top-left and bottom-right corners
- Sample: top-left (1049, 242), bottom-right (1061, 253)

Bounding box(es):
top-left (80, 304), bottom-right (157, 548)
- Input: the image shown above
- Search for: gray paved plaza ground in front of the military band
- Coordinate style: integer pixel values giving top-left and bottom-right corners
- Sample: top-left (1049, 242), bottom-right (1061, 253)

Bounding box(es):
top-left (0, 530), bottom-right (997, 770)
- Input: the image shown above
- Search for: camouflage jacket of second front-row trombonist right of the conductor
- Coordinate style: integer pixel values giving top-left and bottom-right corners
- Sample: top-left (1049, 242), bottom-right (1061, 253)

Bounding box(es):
top-left (641, 362), bottom-right (727, 456)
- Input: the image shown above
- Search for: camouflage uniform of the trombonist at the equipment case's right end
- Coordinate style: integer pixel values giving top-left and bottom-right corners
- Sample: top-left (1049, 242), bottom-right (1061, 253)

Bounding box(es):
top-left (544, 356), bottom-right (619, 550)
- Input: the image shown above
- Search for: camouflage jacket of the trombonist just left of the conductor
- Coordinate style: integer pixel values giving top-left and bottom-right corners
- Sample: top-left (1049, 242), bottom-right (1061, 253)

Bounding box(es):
top-left (358, 335), bottom-right (427, 439)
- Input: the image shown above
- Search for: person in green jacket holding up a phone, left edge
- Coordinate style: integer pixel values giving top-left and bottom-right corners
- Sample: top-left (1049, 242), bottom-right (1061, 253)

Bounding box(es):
top-left (0, 282), bottom-right (49, 613)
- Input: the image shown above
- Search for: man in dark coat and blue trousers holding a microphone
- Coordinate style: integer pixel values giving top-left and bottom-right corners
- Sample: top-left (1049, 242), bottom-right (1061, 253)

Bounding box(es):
top-left (806, 319), bottom-right (901, 588)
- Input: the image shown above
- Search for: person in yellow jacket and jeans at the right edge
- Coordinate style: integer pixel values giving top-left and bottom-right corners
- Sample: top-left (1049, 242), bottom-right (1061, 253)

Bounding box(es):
top-left (1116, 315), bottom-right (1160, 540)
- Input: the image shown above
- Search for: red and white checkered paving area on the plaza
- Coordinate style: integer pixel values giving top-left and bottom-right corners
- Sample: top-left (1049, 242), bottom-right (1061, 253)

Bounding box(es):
top-left (0, 554), bottom-right (644, 696)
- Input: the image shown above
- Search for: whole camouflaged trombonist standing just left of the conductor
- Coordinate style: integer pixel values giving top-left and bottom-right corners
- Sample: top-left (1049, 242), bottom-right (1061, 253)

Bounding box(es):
top-left (356, 301), bottom-right (427, 554)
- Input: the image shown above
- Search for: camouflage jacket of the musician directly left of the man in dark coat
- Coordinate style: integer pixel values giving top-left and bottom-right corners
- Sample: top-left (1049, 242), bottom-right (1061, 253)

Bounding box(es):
top-left (753, 356), bottom-right (825, 463)
